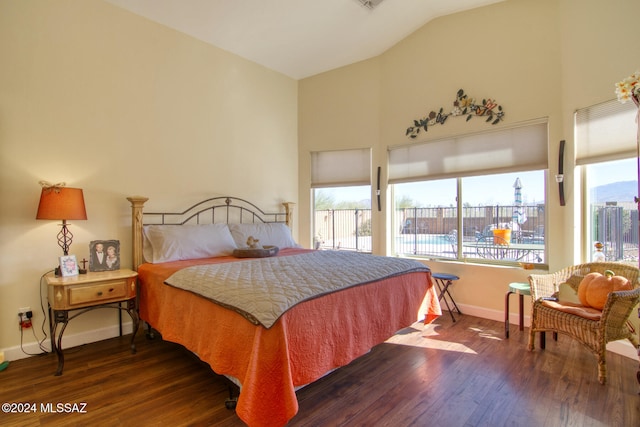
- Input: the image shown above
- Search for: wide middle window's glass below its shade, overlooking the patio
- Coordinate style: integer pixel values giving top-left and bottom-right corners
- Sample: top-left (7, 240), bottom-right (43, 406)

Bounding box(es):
top-left (394, 170), bottom-right (545, 263)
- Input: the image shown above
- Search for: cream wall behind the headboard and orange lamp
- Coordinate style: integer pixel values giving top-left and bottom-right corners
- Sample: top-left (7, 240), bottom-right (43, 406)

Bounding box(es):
top-left (0, 0), bottom-right (298, 358)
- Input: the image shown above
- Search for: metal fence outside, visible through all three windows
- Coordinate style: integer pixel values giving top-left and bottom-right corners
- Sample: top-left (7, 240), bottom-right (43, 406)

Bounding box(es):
top-left (314, 204), bottom-right (638, 263)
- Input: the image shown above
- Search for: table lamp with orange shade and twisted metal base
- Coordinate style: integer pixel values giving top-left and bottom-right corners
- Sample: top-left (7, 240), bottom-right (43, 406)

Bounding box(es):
top-left (36, 182), bottom-right (87, 255)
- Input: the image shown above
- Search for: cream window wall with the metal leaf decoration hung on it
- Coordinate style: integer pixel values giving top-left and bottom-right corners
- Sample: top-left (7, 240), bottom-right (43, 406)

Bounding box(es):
top-left (299, 0), bottom-right (640, 342)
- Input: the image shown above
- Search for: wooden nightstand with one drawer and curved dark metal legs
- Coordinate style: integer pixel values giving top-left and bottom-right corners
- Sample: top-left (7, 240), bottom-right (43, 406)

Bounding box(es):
top-left (45, 269), bottom-right (140, 375)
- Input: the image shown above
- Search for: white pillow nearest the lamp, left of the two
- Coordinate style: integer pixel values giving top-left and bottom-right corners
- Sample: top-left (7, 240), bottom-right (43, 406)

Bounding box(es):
top-left (143, 224), bottom-right (237, 264)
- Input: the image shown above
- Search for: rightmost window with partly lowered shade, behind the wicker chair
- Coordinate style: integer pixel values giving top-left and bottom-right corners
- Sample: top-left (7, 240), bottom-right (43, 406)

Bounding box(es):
top-left (575, 100), bottom-right (639, 264)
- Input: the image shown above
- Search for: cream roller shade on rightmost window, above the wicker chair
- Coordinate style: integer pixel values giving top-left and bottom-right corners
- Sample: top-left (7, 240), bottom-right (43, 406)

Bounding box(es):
top-left (575, 99), bottom-right (638, 165)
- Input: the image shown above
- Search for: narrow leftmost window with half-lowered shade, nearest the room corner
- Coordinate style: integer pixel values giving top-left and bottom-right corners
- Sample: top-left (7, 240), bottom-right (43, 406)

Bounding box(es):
top-left (311, 148), bottom-right (372, 252)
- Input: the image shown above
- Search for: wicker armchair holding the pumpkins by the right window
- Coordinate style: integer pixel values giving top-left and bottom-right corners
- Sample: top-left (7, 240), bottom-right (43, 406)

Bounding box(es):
top-left (528, 262), bottom-right (640, 384)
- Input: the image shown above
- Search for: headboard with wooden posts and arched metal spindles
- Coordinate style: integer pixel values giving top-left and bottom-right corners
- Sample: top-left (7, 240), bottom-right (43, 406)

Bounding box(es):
top-left (127, 196), bottom-right (295, 270)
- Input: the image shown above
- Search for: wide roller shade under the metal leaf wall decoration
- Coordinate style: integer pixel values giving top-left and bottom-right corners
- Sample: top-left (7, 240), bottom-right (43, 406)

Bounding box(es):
top-left (389, 120), bottom-right (549, 183)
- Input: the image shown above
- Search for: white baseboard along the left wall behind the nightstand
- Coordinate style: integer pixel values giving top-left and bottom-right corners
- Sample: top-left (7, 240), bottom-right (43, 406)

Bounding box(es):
top-left (0, 322), bottom-right (133, 360)
